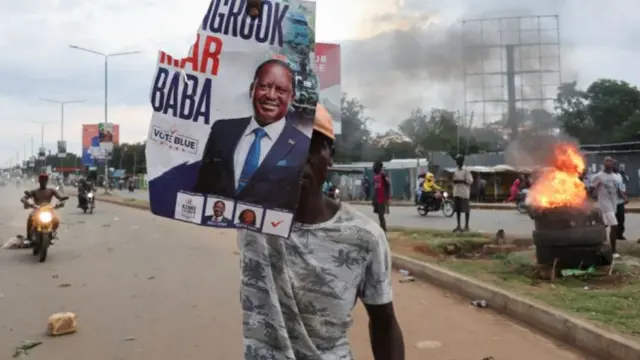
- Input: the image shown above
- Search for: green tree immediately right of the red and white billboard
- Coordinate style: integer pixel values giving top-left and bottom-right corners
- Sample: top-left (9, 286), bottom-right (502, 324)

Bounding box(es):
top-left (335, 93), bottom-right (371, 162)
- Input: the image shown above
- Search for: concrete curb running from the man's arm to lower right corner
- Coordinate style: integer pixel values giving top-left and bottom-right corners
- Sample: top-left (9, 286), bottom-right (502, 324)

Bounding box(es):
top-left (392, 254), bottom-right (640, 360)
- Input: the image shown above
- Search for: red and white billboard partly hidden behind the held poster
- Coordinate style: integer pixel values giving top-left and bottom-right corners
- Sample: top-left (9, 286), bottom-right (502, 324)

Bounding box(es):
top-left (316, 43), bottom-right (342, 134)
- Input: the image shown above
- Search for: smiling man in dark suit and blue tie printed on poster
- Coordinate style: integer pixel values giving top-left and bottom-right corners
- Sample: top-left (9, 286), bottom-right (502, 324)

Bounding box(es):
top-left (193, 59), bottom-right (310, 210)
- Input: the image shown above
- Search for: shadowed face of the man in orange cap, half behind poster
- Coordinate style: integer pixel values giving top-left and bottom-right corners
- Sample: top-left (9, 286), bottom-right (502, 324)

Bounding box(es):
top-left (300, 132), bottom-right (333, 194)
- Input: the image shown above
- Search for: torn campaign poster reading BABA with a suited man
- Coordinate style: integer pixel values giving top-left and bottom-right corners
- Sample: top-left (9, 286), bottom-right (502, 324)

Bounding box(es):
top-left (146, 0), bottom-right (318, 237)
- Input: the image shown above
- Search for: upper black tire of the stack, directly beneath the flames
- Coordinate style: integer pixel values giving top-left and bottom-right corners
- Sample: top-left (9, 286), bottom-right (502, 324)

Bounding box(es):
top-left (533, 225), bottom-right (607, 247)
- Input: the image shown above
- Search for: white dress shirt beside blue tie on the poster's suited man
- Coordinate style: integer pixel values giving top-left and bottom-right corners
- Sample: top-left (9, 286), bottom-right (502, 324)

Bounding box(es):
top-left (233, 117), bottom-right (286, 188)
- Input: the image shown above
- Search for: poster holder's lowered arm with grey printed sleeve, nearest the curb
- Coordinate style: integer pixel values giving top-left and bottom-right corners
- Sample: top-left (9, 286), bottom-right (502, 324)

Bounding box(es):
top-left (359, 229), bottom-right (404, 360)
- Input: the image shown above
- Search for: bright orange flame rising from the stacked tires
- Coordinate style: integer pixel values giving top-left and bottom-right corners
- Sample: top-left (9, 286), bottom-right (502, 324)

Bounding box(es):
top-left (527, 143), bottom-right (587, 208)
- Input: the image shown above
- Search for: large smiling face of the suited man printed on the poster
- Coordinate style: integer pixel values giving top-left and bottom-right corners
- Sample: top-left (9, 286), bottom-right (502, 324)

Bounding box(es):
top-left (251, 64), bottom-right (293, 125)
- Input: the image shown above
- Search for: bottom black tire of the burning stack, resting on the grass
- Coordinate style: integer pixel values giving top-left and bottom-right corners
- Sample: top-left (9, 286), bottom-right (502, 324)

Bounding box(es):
top-left (536, 244), bottom-right (613, 269)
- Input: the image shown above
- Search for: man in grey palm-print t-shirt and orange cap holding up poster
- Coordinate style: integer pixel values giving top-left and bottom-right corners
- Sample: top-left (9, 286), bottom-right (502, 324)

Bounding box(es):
top-left (238, 106), bottom-right (404, 360)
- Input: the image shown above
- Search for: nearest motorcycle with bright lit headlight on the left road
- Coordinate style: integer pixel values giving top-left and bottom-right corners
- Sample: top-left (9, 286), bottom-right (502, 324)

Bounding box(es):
top-left (28, 202), bottom-right (64, 262)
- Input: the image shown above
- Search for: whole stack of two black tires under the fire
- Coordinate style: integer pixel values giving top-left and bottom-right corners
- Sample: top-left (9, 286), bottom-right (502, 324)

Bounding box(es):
top-left (533, 225), bottom-right (613, 269)
